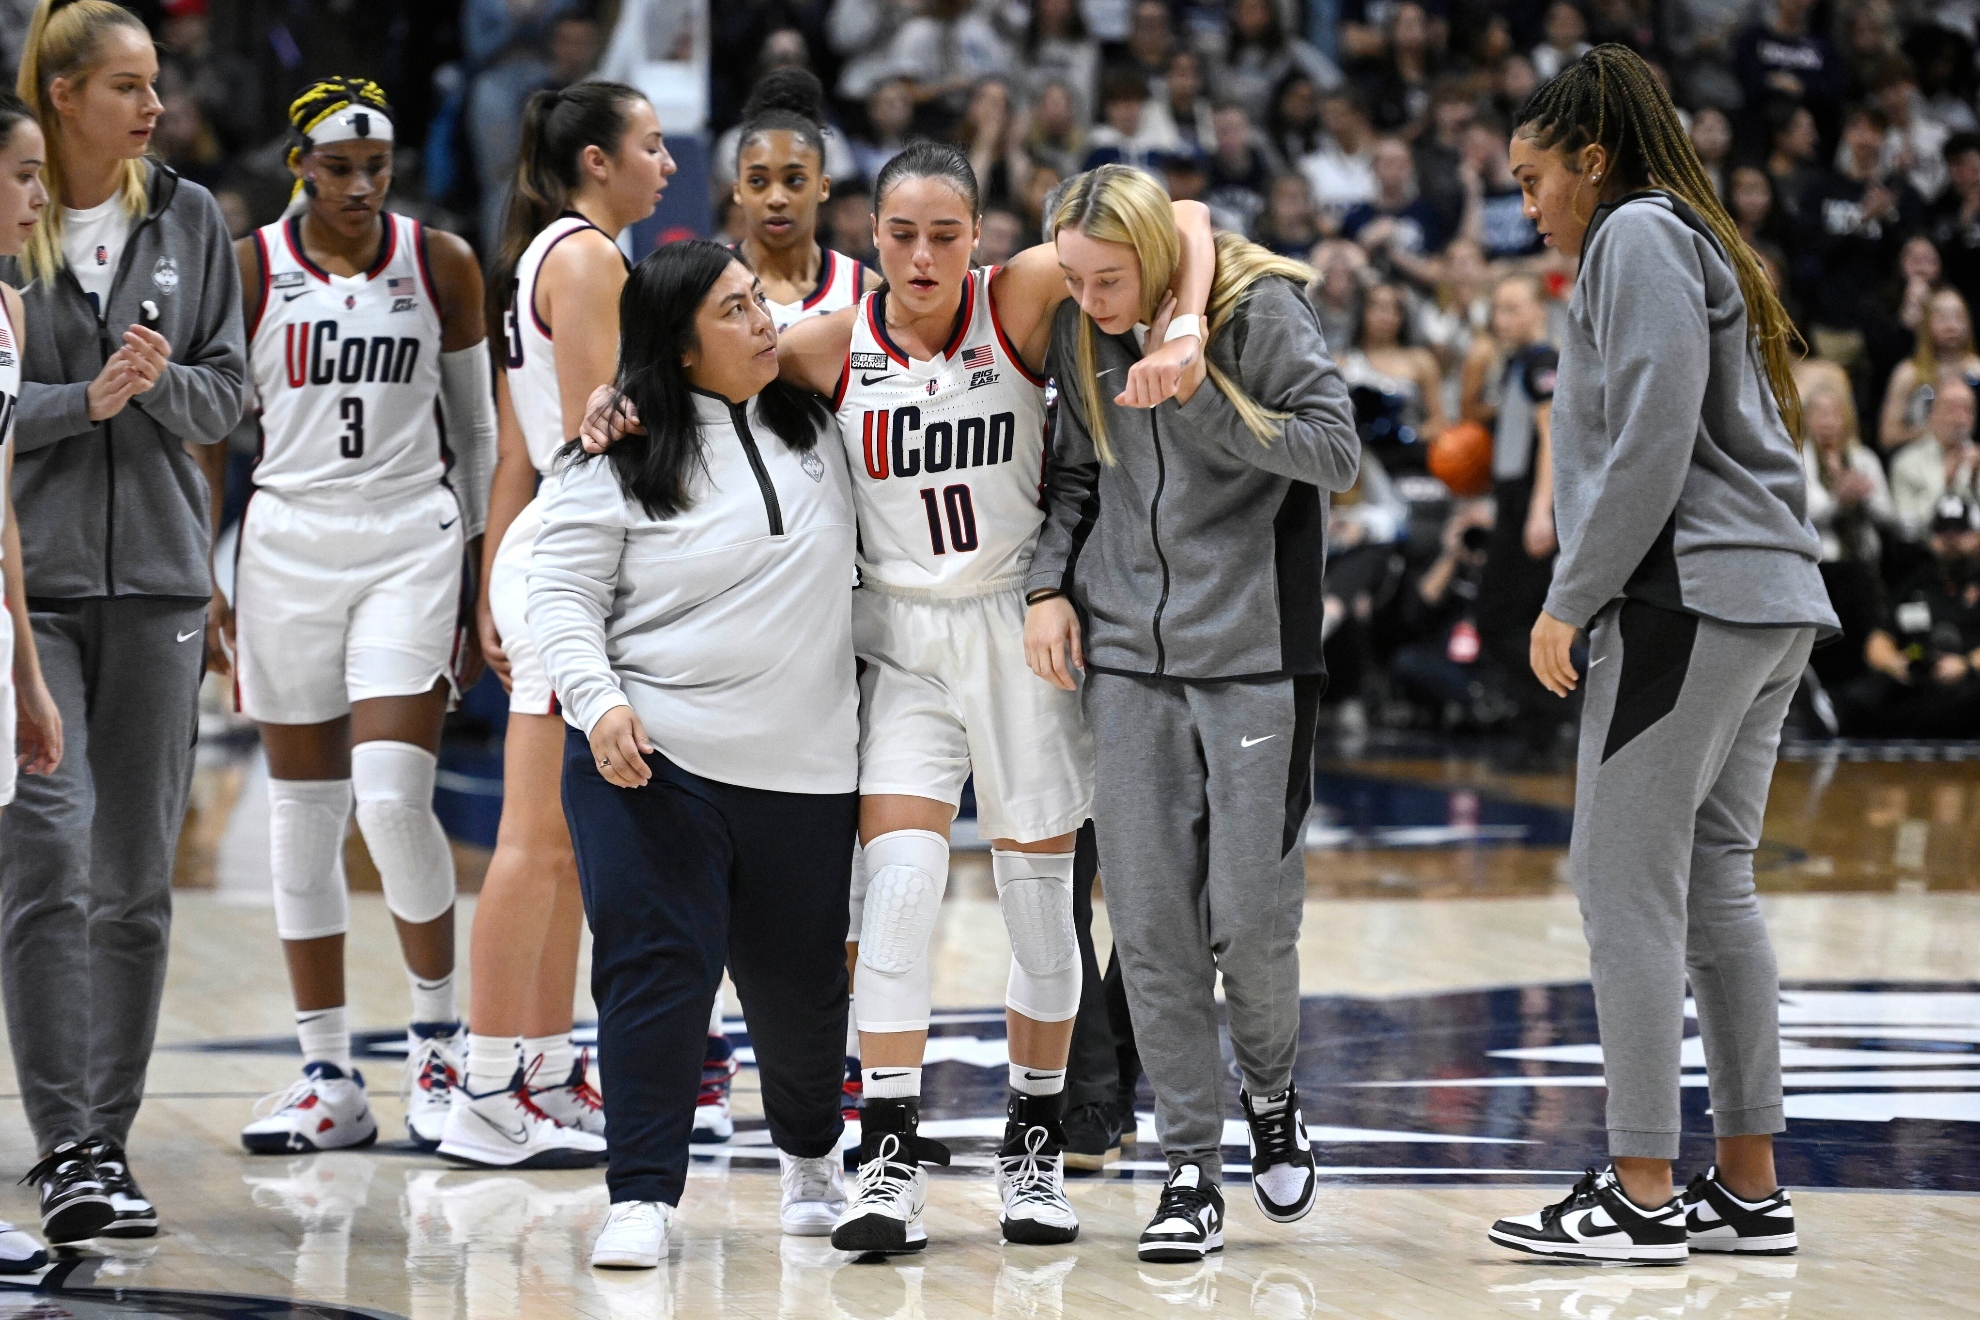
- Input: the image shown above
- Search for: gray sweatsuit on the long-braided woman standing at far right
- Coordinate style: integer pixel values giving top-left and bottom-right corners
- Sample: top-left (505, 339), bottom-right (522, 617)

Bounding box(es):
top-left (1546, 192), bottom-right (1837, 1160)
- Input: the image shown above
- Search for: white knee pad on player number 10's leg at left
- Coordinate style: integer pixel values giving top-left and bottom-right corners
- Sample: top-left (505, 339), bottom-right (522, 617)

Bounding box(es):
top-left (853, 829), bottom-right (948, 1031)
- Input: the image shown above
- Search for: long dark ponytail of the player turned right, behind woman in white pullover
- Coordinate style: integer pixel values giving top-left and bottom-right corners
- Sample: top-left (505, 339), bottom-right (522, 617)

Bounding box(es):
top-left (485, 83), bottom-right (645, 344)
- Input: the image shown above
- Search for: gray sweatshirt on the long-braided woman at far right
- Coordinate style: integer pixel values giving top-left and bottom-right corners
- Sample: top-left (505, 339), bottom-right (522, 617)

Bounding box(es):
top-left (1546, 192), bottom-right (1837, 631)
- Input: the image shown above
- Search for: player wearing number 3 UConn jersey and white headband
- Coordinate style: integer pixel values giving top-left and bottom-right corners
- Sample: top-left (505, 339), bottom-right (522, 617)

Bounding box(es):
top-left (234, 77), bottom-right (495, 1154)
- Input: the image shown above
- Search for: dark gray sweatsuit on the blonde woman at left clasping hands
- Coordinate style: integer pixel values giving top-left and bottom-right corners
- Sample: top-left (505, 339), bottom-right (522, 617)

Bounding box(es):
top-left (0, 162), bottom-right (248, 1152)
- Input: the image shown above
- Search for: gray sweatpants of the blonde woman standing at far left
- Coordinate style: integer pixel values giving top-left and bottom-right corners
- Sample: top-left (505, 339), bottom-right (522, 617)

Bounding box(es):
top-left (0, 596), bottom-right (206, 1152)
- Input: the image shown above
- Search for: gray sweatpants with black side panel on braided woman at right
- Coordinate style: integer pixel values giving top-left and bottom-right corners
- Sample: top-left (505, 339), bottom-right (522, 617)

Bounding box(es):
top-left (1568, 602), bottom-right (1816, 1160)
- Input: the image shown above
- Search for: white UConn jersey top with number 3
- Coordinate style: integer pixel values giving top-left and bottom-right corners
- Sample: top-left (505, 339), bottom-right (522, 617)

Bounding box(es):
top-left (248, 212), bottom-right (447, 501)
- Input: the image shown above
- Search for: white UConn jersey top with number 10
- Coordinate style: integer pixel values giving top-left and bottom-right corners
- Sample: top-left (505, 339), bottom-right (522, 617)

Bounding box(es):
top-left (832, 265), bottom-right (1045, 596)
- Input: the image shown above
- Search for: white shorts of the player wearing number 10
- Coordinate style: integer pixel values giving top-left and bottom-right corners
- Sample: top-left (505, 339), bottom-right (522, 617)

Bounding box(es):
top-left (853, 584), bottom-right (1093, 843)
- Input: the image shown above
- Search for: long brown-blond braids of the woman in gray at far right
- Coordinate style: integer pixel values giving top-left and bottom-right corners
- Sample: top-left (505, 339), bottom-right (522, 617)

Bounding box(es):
top-left (1515, 44), bottom-right (1802, 443)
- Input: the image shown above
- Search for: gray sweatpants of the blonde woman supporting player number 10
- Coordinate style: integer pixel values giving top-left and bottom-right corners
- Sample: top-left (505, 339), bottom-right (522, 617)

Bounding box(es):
top-left (1083, 673), bottom-right (1325, 1181)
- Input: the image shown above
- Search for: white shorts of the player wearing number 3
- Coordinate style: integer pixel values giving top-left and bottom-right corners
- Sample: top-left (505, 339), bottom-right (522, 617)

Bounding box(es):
top-left (234, 485), bottom-right (463, 724)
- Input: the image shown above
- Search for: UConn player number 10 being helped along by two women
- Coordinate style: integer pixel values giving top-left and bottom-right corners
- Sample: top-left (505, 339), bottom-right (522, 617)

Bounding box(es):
top-left (586, 142), bottom-right (1216, 1253)
